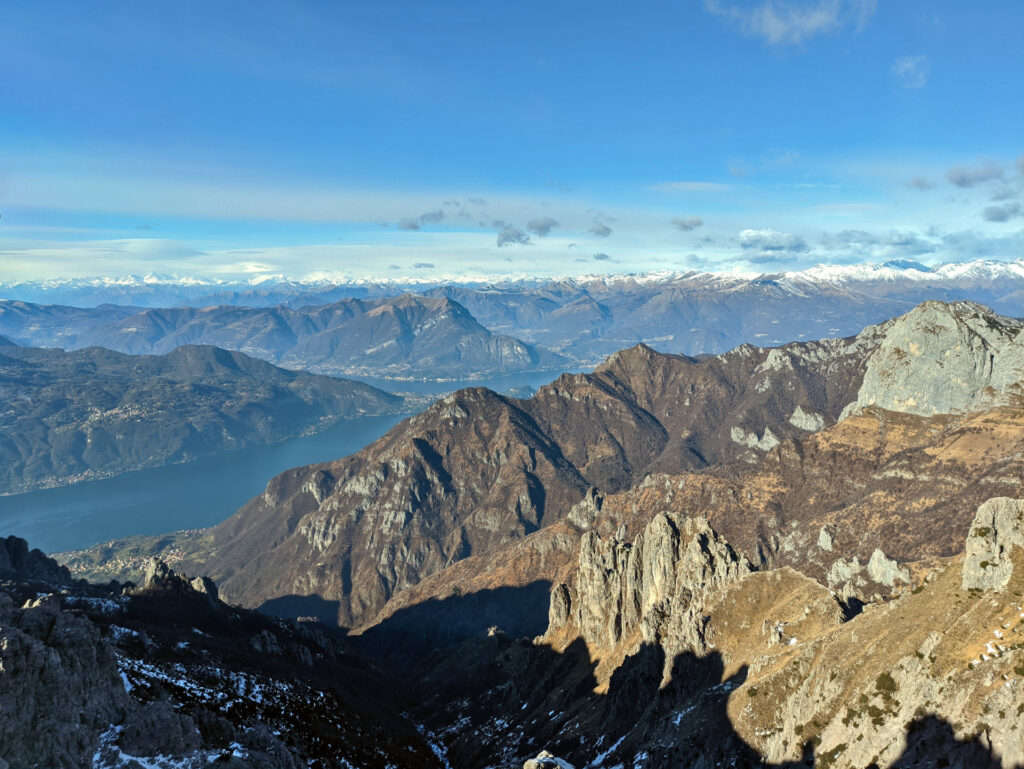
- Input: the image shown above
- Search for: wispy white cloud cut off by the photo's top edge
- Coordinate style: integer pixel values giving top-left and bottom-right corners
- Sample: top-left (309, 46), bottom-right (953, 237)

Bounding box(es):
top-left (705, 0), bottom-right (876, 45)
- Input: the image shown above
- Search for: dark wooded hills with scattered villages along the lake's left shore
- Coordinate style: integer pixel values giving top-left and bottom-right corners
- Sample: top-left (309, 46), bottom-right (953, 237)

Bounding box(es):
top-left (0, 337), bottom-right (408, 494)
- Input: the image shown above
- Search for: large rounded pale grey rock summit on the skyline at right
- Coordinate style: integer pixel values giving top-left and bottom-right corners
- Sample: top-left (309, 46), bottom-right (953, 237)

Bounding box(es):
top-left (844, 302), bottom-right (1024, 417)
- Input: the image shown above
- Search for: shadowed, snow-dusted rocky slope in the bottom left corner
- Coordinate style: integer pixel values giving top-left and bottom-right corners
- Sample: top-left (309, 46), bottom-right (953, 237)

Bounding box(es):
top-left (0, 538), bottom-right (440, 769)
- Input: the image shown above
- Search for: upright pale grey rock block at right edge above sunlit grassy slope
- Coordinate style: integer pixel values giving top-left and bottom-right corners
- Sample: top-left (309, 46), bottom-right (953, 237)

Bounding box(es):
top-left (963, 497), bottom-right (1024, 590)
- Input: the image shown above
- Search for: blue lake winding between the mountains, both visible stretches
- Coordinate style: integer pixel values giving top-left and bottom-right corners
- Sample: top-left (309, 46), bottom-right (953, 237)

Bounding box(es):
top-left (0, 372), bottom-right (569, 553)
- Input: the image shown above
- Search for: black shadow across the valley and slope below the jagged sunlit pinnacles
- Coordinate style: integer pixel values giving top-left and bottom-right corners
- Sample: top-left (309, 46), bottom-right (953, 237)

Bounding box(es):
top-left (357, 582), bottom-right (1004, 769)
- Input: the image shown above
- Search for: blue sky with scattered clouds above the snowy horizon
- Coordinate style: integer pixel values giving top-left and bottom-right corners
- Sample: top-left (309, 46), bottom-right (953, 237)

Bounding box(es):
top-left (0, 0), bottom-right (1024, 281)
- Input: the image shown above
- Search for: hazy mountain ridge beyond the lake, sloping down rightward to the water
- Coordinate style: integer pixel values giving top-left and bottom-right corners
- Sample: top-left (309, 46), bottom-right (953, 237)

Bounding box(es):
top-left (0, 294), bottom-right (568, 379)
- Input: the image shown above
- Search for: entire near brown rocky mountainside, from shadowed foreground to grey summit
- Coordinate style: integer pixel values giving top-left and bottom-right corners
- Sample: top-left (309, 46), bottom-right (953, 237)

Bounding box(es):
top-left (19, 302), bottom-right (1024, 769)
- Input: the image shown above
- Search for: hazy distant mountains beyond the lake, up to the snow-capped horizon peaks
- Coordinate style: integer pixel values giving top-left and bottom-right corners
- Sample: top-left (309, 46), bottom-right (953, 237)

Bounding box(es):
top-left (0, 261), bottom-right (1024, 378)
